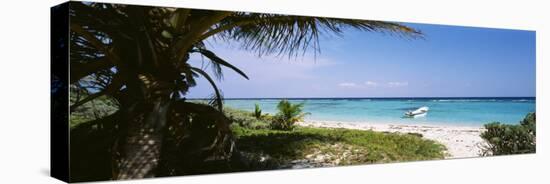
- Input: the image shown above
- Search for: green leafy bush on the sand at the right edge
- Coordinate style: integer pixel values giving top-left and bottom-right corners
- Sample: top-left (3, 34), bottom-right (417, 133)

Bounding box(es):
top-left (481, 113), bottom-right (536, 155)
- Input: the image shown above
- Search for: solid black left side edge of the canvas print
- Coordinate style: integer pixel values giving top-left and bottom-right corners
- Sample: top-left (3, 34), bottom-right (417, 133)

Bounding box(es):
top-left (50, 2), bottom-right (70, 182)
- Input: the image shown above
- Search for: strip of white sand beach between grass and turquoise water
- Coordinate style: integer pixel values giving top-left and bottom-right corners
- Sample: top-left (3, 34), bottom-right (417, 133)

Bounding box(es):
top-left (298, 121), bottom-right (486, 158)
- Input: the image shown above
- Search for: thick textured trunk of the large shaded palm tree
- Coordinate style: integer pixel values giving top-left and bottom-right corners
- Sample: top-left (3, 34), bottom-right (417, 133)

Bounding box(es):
top-left (113, 8), bottom-right (175, 179)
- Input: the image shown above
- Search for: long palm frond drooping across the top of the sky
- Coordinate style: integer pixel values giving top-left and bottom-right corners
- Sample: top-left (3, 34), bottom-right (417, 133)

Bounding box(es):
top-left (216, 13), bottom-right (422, 57)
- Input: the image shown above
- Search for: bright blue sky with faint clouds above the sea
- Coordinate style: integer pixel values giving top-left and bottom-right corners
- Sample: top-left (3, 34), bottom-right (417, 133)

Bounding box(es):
top-left (188, 24), bottom-right (535, 98)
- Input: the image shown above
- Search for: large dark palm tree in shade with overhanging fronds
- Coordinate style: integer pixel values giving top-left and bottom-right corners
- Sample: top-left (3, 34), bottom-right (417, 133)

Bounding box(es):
top-left (69, 2), bottom-right (421, 179)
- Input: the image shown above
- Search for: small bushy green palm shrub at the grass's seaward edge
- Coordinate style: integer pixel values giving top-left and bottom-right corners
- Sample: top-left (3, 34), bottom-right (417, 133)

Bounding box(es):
top-left (271, 100), bottom-right (309, 130)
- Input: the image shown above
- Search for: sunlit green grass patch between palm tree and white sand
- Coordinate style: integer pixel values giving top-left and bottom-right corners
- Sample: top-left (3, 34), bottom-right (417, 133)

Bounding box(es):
top-left (226, 108), bottom-right (446, 167)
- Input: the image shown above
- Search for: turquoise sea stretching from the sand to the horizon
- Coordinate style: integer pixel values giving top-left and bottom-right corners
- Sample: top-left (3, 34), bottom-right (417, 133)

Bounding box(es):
top-left (219, 97), bottom-right (535, 126)
